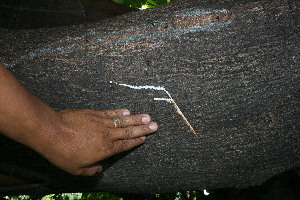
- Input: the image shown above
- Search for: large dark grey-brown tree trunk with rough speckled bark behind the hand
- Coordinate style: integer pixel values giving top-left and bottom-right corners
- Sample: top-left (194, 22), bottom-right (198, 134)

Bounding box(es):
top-left (0, 0), bottom-right (300, 193)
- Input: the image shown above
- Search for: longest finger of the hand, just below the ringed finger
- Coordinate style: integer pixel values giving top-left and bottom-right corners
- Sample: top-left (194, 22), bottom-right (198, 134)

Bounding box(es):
top-left (111, 122), bottom-right (158, 140)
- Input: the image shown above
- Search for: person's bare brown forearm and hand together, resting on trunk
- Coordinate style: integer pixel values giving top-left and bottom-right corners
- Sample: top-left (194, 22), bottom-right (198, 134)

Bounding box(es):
top-left (0, 64), bottom-right (158, 176)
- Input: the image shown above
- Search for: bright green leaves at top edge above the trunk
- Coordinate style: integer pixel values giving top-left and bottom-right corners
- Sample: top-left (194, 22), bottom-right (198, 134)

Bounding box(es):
top-left (113, 0), bottom-right (172, 9)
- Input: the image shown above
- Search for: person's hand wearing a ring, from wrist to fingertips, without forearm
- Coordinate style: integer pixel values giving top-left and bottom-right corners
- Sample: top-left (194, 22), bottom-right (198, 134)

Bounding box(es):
top-left (38, 109), bottom-right (158, 176)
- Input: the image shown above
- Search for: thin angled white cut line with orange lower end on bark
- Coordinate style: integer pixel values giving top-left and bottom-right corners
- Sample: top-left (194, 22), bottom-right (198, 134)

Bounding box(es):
top-left (110, 81), bottom-right (198, 136)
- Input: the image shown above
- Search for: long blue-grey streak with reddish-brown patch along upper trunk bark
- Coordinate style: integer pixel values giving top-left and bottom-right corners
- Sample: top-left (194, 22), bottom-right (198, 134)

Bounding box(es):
top-left (5, 8), bottom-right (233, 67)
